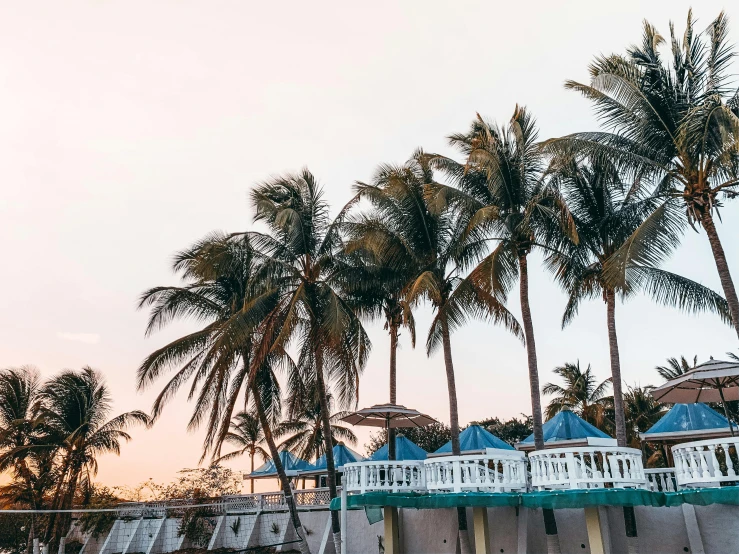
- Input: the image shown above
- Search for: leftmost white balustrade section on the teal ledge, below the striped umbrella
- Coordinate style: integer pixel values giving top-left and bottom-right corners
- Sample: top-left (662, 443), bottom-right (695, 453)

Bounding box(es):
top-left (344, 460), bottom-right (426, 493)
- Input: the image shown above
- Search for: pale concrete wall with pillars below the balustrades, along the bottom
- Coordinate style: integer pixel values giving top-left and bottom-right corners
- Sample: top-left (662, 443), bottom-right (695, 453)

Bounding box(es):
top-left (63, 504), bottom-right (739, 554)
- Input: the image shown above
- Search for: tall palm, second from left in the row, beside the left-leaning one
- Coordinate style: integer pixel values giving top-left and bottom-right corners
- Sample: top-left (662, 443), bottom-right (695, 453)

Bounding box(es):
top-left (248, 169), bottom-right (371, 551)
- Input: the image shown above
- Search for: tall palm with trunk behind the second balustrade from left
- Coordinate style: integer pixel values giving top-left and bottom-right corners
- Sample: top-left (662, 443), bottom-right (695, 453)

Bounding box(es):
top-left (355, 151), bottom-right (522, 551)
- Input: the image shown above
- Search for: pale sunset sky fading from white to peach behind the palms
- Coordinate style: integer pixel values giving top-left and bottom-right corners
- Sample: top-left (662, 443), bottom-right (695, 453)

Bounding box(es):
top-left (0, 0), bottom-right (739, 485)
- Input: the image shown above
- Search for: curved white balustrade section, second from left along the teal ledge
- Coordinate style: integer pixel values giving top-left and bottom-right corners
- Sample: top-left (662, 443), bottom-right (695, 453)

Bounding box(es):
top-left (424, 448), bottom-right (527, 492)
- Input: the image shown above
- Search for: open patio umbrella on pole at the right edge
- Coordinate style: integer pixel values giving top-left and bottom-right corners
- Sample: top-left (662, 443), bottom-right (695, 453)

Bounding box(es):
top-left (651, 358), bottom-right (739, 437)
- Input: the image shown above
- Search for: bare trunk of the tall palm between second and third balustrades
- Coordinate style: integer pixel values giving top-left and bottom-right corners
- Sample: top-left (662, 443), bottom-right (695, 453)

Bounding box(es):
top-left (518, 254), bottom-right (560, 554)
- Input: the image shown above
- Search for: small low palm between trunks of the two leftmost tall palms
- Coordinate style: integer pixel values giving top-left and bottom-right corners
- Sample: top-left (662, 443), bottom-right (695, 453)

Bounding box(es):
top-left (275, 389), bottom-right (357, 460)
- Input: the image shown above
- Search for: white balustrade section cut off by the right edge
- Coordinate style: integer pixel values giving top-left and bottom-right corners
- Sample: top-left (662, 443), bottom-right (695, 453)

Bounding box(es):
top-left (672, 437), bottom-right (739, 487)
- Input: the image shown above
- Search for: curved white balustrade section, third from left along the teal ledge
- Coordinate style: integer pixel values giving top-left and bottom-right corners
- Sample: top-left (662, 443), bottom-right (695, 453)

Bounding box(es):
top-left (529, 447), bottom-right (647, 490)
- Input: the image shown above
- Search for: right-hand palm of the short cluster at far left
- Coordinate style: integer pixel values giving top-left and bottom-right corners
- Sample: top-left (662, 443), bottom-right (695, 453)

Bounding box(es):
top-left (39, 367), bottom-right (150, 544)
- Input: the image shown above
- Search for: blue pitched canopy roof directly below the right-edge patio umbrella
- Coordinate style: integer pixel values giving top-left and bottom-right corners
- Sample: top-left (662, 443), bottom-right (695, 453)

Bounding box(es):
top-left (641, 402), bottom-right (730, 440)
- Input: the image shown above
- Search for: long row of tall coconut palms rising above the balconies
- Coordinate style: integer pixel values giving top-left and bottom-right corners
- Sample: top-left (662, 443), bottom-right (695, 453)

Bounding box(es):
top-left (138, 9), bottom-right (739, 549)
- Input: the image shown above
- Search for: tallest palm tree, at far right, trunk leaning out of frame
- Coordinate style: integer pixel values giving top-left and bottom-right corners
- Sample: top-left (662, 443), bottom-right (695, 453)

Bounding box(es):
top-left (548, 11), bottom-right (739, 335)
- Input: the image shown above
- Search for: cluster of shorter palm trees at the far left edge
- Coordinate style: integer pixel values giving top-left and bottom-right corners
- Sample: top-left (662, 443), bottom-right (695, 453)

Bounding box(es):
top-left (0, 367), bottom-right (149, 546)
